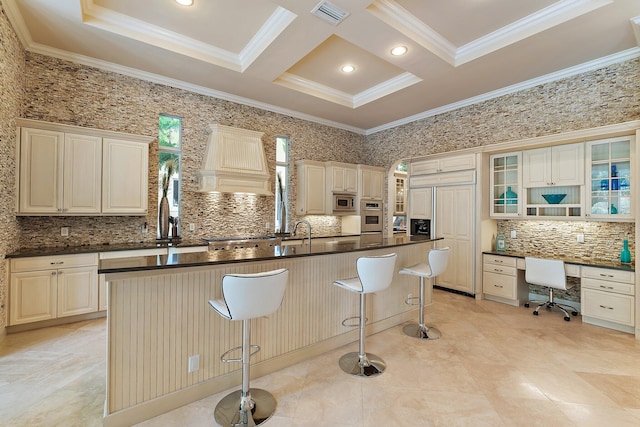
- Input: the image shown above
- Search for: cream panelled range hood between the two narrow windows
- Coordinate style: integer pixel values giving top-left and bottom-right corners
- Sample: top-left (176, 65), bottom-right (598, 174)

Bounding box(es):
top-left (196, 124), bottom-right (273, 196)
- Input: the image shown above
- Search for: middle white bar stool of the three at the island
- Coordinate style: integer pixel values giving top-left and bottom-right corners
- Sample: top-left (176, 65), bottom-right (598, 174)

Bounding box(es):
top-left (333, 254), bottom-right (397, 377)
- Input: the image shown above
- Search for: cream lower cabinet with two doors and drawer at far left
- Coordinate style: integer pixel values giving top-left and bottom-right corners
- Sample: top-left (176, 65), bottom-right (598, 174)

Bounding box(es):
top-left (9, 253), bottom-right (98, 326)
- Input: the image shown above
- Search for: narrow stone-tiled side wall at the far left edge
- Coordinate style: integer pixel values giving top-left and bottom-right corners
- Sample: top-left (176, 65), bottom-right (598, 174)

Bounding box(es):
top-left (0, 9), bottom-right (25, 334)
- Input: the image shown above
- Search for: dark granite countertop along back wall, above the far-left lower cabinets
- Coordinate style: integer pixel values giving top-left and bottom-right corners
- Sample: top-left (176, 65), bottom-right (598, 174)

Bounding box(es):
top-left (5, 239), bottom-right (207, 258)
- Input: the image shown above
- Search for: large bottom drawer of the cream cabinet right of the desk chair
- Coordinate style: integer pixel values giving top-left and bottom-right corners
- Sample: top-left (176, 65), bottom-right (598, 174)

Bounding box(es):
top-left (581, 288), bottom-right (635, 326)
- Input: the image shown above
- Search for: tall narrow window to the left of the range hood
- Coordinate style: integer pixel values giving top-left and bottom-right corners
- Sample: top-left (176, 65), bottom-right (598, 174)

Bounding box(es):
top-left (158, 114), bottom-right (182, 237)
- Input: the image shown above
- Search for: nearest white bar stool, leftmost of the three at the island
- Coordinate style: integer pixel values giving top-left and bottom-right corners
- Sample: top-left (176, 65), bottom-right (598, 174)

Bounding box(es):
top-left (209, 268), bottom-right (289, 427)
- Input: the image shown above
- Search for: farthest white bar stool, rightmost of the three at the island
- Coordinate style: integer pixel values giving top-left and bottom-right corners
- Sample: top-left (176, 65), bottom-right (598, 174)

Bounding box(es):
top-left (399, 248), bottom-right (451, 340)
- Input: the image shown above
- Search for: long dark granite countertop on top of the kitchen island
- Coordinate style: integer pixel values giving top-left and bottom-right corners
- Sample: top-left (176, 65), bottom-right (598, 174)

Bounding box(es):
top-left (98, 235), bottom-right (441, 274)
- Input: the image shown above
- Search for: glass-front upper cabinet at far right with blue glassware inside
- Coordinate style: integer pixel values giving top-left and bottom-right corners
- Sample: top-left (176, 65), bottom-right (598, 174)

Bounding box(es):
top-left (586, 136), bottom-right (635, 220)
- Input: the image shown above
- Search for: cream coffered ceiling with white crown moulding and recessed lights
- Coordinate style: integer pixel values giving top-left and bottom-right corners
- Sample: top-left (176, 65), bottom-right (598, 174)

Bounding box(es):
top-left (1, 0), bottom-right (640, 133)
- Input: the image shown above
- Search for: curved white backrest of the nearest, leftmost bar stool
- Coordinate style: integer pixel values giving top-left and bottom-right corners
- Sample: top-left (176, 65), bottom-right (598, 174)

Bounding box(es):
top-left (222, 268), bottom-right (289, 320)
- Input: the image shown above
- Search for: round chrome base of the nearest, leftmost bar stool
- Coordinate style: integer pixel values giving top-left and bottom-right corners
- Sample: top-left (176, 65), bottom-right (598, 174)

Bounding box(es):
top-left (214, 388), bottom-right (277, 427)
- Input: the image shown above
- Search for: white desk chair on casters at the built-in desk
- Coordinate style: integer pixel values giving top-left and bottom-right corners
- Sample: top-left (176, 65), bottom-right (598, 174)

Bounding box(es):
top-left (524, 257), bottom-right (578, 322)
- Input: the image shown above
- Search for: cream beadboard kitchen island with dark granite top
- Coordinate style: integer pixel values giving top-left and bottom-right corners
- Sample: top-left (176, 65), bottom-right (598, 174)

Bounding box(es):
top-left (98, 235), bottom-right (438, 426)
